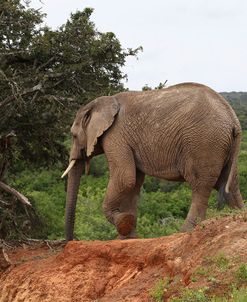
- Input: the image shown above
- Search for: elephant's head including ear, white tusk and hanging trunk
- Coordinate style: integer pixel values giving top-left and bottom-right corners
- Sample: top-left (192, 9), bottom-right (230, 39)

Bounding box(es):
top-left (62, 97), bottom-right (119, 241)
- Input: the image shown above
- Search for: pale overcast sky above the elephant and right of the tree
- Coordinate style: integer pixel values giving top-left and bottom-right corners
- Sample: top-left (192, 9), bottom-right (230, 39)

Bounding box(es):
top-left (31, 0), bottom-right (247, 92)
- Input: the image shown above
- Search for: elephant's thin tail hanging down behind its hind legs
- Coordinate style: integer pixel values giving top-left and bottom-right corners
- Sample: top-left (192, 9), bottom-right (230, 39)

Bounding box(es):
top-left (218, 127), bottom-right (241, 208)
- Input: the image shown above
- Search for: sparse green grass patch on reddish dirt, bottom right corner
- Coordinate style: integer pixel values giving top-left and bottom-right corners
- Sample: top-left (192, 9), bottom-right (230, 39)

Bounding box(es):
top-left (149, 260), bottom-right (247, 302)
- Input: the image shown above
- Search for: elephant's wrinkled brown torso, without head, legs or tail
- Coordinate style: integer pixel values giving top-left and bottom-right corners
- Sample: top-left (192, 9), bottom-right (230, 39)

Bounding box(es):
top-left (111, 83), bottom-right (240, 180)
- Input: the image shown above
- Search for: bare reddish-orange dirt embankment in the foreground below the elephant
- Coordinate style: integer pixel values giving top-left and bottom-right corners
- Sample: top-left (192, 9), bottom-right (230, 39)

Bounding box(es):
top-left (0, 213), bottom-right (247, 302)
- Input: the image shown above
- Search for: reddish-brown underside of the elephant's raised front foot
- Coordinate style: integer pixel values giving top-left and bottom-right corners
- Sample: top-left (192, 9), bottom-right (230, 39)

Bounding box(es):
top-left (115, 213), bottom-right (136, 236)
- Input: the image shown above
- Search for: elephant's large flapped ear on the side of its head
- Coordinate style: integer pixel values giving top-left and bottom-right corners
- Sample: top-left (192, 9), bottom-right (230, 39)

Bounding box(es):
top-left (87, 97), bottom-right (120, 156)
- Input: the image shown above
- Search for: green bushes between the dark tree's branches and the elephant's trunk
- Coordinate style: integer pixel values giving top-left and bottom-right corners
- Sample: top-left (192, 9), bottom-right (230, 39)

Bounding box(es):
top-left (12, 168), bottom-right (65, 239)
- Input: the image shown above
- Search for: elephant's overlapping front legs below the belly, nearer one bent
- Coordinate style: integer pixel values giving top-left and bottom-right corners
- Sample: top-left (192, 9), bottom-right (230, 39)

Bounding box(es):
top-left (103, 166), bottom-right (145, 239)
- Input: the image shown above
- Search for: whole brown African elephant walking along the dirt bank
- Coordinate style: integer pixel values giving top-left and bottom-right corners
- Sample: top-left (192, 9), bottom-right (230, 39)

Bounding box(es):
top-left (63, 83), bottom-right (243, 240)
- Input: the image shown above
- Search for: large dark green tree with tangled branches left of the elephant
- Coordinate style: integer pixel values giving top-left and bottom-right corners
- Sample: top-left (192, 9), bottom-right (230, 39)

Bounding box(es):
top-left (0, 0), bottom-right (140, 239)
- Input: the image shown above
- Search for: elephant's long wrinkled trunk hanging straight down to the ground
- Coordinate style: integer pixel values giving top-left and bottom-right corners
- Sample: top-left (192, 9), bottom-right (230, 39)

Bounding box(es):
top-left (65, 160), bottom-right (84, 241)
